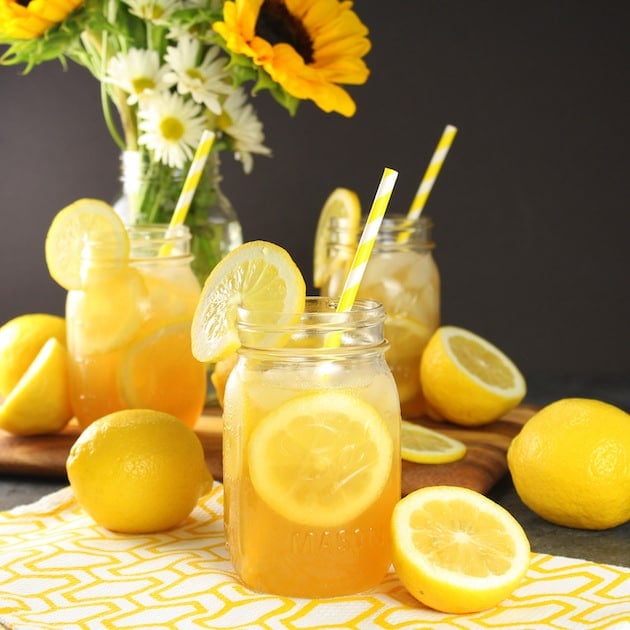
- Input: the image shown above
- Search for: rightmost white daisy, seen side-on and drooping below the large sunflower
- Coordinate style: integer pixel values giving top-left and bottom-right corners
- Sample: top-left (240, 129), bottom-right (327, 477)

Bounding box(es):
top-left (218, 89), bottom-right (271, 173)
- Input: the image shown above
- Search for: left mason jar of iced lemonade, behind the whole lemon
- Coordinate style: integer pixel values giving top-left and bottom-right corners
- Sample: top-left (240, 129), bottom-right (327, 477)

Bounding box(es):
top-left (66, 225), bottom-right (206, 427)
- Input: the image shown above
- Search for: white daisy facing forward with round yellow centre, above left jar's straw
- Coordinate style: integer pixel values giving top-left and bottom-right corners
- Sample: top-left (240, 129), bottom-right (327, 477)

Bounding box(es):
top-left (138, 92), bottom-right (205, 168)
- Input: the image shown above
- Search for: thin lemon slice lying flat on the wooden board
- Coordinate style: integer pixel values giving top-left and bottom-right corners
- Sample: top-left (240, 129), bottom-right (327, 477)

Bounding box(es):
top-left (400, 420), bottom-right (466, 464)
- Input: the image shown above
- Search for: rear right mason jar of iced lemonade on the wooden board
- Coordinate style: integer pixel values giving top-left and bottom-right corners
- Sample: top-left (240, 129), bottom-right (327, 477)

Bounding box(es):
top-left (321, 214), bottom-right (440, 418)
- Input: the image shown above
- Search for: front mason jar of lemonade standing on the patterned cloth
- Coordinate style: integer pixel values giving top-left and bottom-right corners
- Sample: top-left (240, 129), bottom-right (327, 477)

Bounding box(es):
top-left (223, 298), bottom-right (401, 597)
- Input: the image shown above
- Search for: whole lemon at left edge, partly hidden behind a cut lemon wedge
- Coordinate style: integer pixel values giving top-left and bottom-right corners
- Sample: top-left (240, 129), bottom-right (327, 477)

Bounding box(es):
top-left (0, 313), bottom-right (66, 397)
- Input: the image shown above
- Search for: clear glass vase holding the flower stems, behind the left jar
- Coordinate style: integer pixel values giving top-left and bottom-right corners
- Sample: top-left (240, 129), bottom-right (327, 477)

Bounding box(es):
top-left (113, 151), bottom-right (243, 285)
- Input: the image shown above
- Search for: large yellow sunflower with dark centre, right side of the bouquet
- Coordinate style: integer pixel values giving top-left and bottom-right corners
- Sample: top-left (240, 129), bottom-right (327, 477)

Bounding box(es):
top-left (214, 0), bottom-right (370, 116)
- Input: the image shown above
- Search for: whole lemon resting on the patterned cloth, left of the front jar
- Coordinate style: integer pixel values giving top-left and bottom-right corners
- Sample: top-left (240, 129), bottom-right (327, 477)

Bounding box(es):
top-left (66, 409), bottom-right (212, 534)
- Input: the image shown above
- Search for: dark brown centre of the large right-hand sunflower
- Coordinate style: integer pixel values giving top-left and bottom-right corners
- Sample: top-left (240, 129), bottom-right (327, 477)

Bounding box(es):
top-left (256, 0), bottom-right (314, 64)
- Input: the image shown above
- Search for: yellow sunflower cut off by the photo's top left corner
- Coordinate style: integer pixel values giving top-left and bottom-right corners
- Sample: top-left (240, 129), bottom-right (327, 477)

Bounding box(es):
top-left (0, 0), bottom-right (85, 39)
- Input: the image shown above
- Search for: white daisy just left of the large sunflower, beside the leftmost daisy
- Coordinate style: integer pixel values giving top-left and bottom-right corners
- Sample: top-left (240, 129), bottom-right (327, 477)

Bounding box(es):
top-left (164, 37), bottom-right (232, 114)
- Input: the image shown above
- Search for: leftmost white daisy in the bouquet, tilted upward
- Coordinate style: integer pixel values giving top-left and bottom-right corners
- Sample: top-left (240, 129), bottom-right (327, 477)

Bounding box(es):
top-left (105, 48), bottom-right (166, 105)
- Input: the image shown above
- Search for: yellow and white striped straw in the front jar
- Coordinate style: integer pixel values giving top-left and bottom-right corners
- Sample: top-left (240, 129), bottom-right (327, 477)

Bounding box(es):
top-left (337, 168), bottom-right (398, 313)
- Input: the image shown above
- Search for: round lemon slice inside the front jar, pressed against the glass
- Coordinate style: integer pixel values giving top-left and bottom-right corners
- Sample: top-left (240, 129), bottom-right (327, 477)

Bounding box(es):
top-left (248, 392), bottom-right (394, 527)
